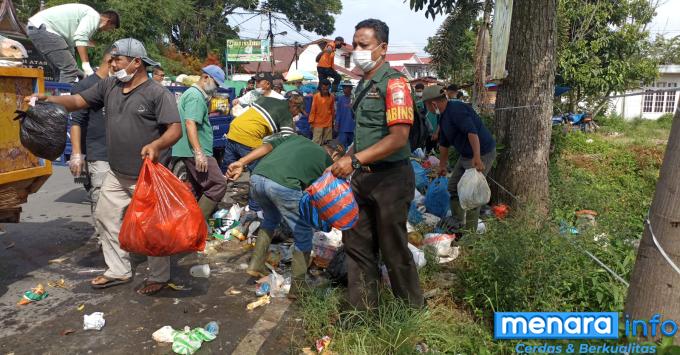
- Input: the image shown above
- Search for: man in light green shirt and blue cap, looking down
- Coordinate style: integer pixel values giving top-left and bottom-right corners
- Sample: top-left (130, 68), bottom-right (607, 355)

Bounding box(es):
top-left (172, 65), bottom-right (227, 219)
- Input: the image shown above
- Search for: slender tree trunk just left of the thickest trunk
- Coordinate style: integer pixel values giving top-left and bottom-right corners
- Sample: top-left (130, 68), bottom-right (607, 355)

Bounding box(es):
top-left (472, 0), bottom-right (493, 112)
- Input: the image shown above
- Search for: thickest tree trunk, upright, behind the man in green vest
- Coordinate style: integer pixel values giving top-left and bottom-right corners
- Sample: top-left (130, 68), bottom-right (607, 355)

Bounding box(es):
top-left (491, 0), bottom-right (557, 214)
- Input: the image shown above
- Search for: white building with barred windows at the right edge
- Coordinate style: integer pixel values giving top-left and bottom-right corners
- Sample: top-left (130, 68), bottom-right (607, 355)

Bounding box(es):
top-left (612, 65), bottom-right (680, 120)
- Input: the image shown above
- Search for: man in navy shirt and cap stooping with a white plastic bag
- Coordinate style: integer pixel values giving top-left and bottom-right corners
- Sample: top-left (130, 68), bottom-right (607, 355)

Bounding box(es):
top-left (423, 85), bottom-right (496, 231)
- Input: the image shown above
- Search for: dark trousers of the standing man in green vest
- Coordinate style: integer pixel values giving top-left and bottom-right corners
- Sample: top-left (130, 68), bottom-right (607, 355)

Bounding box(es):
top-left (342, 164), bottom-right (423, 309)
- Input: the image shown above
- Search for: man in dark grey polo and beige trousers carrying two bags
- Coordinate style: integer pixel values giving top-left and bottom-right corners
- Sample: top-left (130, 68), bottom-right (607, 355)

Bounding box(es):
top-left (26, 38), bottom-right (182, 295)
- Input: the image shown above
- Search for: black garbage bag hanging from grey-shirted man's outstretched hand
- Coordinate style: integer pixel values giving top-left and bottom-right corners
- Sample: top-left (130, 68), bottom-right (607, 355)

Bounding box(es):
top-left (15, 101), bottom-right (68, 160)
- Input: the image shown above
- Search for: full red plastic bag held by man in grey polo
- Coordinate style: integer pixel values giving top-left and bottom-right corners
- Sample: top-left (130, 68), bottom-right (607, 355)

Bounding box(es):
top-left (118, 159), bottom-right (208, 256)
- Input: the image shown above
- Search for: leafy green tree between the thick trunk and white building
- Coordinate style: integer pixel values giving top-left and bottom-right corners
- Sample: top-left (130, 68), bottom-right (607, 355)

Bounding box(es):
top-left (555, 0), bottom-right (657, 109)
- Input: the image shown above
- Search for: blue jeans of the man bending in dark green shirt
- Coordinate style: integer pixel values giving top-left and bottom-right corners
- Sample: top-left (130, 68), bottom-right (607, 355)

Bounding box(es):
top-left (250, 175), bottom-right (314, 252)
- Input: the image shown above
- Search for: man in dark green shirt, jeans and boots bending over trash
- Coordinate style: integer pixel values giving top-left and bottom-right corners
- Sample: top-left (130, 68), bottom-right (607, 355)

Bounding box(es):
top-left (227, 132), bottom-right (344, 299)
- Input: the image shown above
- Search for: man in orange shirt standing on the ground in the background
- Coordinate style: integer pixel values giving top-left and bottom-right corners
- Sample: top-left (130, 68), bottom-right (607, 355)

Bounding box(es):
top-left (309, 79), bottom-right (335, 145)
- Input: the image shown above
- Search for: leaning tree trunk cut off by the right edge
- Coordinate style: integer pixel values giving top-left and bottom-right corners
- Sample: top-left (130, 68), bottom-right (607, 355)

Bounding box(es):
top-left (626, 110), bottom-right (680, 335)
